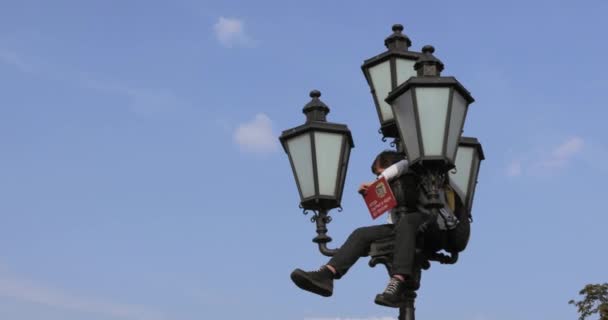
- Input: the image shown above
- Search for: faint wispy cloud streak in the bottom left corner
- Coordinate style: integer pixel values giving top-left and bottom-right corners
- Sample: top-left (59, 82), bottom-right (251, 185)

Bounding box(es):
top-left (0, 269), bottom-right (165, 320)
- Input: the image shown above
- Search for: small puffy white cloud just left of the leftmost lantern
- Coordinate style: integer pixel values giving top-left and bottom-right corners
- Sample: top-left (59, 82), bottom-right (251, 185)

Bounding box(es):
top-left (233, 113), bottom-right (277, 153)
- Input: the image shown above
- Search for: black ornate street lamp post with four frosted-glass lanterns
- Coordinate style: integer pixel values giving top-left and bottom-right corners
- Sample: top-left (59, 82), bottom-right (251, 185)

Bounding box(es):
top-left (279, 24), bottom-right (484, 320)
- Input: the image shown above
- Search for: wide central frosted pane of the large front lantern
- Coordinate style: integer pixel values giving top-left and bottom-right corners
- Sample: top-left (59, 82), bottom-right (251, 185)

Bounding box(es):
top-left (416, 88), bottom-right (450, 156)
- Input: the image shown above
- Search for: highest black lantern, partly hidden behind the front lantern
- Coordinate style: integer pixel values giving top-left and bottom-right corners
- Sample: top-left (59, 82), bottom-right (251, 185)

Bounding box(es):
top-left (361, 24), bottom-right (420, 138)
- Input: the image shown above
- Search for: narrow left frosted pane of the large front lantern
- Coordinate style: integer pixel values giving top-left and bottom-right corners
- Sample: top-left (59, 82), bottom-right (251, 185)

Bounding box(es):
top-left (393, 90), bottom-right (420, 161)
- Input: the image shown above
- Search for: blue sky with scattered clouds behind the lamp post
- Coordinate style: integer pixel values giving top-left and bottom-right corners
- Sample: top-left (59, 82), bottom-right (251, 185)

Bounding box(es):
top-left (0, 0), bottom-right (608, 320)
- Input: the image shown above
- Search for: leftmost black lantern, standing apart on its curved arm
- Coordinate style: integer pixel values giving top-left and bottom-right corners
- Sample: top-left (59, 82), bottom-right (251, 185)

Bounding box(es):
top-left (279, 90), bottom-right (355, 256)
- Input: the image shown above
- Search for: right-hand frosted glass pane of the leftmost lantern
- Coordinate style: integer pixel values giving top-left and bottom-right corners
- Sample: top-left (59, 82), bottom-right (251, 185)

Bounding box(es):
top-left (315, 132), bottom-right (342, 197)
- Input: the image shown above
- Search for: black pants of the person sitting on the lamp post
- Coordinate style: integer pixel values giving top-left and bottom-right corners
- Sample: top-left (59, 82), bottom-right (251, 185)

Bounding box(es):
top-left (327, 212), bottom-right (426, 278)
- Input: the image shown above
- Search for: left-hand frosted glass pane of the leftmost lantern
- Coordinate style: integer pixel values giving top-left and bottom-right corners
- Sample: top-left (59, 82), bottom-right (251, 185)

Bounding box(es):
top-left (287, 134), bottom-right (315, 198)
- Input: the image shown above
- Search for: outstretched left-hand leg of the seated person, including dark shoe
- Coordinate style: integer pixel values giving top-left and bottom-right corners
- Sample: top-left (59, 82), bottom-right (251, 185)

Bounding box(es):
top-left (291, 224), bottom-right (393, 297)
